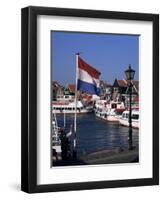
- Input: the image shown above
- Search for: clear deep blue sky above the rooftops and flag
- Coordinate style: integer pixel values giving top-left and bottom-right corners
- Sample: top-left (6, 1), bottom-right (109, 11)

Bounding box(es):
top-left (51, 32), bottom-right (139, 85)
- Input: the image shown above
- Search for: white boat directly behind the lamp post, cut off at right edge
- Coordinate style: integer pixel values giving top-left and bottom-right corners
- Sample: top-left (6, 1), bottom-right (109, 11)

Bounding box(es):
top-left (119, 110), bottom-right (139, 128)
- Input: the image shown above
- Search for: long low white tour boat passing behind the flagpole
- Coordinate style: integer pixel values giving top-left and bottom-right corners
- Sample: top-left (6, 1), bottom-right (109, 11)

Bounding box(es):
top-left (52, 101), bottom-right (93, 114)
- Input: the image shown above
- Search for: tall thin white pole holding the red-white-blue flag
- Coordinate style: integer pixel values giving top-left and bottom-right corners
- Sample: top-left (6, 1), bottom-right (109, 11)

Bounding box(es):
top-left (73, 53), bottom-right (79, 158)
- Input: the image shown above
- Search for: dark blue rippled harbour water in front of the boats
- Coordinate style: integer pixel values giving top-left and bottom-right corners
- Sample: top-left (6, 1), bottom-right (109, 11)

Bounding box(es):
top-left (57, 113), bottom-right (139, 156)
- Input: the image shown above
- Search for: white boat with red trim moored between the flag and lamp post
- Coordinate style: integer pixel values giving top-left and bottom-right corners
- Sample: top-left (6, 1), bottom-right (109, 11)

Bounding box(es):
top-left (95, 100), bottom-right (125, 122)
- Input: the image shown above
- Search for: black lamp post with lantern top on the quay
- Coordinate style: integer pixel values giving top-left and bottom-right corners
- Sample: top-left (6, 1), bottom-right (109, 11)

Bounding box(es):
top-left (125, 65), bottom-right (135, 150)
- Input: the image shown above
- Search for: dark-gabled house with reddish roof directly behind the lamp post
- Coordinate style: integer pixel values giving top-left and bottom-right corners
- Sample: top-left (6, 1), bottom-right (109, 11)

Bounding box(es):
top-left (112, 79), bottom-right (139, 104)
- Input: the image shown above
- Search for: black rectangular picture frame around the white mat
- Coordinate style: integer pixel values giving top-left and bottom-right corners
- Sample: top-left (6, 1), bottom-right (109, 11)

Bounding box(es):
top-left (21, 6), bottom-right (159, 193)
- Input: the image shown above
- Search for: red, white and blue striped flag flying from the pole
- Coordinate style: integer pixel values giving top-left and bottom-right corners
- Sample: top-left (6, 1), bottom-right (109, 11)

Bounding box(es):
top-left (77, 56), bottom-right (101, 96)
